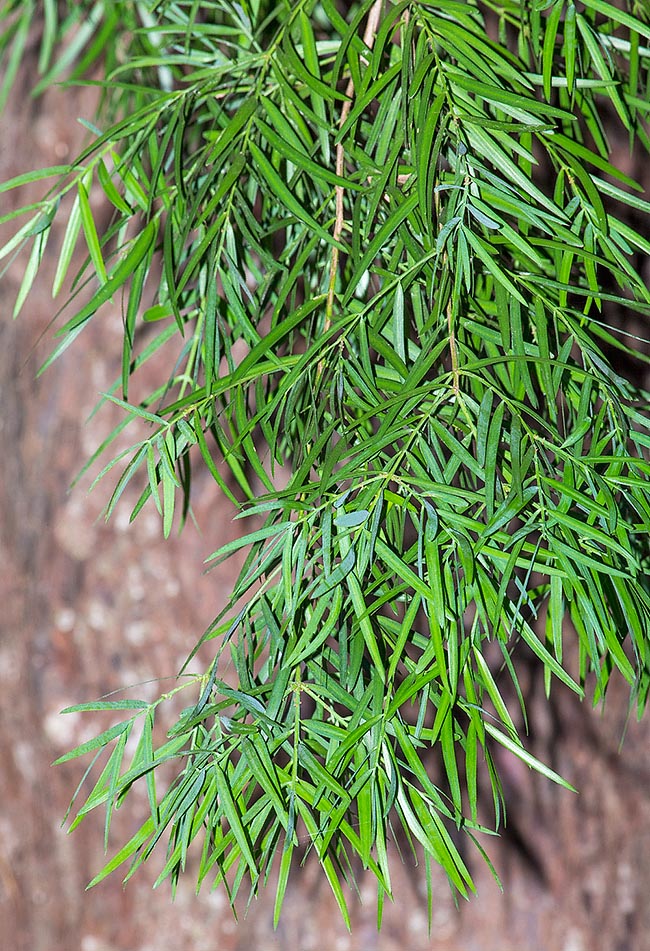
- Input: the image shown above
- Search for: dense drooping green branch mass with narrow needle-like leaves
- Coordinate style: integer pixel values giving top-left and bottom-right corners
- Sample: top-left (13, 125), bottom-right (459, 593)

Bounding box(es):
top-left (0, 0), bottom-right (650, 919)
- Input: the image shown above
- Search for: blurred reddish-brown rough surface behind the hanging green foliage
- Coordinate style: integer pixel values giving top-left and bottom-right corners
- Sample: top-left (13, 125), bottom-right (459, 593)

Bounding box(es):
top-left (0, 59), bottom-right (650, 951)
